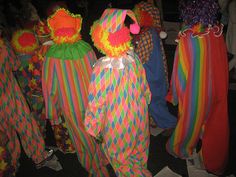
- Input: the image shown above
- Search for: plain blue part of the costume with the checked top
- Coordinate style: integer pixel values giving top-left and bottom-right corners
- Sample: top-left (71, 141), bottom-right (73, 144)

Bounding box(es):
top-left (143, 29), bottom-right (177, 128)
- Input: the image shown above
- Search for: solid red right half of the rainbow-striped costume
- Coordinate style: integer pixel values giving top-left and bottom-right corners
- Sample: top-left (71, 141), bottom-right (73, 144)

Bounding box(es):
top-left (202, 30), bottom-right (229, 175)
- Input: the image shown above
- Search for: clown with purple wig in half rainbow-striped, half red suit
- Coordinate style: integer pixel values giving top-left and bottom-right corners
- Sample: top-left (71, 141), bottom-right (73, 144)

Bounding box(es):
top-left (166, 0), bottom-right (229, 175)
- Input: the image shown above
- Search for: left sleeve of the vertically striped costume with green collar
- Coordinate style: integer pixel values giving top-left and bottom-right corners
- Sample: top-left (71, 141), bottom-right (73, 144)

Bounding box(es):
top-left (42, 58), bottom-right (61, 125)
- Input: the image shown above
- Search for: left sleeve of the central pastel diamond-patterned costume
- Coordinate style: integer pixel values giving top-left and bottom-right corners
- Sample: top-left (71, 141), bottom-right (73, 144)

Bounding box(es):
top-left (84, 66), bottom-right (109, 137)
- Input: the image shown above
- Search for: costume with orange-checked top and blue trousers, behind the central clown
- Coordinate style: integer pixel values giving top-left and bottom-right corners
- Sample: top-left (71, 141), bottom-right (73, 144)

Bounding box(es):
top-left (134, 28), bottom-right (177, 129)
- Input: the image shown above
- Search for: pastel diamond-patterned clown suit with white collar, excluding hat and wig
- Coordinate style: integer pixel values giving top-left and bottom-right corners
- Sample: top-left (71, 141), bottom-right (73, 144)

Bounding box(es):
top-left (85, 50), bottom-right (151, 177)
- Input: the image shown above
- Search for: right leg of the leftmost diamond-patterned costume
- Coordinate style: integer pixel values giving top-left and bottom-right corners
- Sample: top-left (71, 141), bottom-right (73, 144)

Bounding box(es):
top-left (9, 78), bottom-right (47, 163)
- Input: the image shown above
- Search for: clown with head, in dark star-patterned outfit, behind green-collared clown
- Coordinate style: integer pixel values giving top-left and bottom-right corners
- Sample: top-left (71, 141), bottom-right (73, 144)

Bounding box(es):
top-left (31, 21), bottom-right (75, 153)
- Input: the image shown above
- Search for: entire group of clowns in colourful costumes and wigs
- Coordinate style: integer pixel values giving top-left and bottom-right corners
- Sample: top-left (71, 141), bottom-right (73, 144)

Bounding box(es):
top-left (0, 0), bottom-right (235, 177)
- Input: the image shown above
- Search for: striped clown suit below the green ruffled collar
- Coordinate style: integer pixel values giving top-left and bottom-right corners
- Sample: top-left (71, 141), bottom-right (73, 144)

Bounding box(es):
top-left (42, 51), bottom-right (109, 176)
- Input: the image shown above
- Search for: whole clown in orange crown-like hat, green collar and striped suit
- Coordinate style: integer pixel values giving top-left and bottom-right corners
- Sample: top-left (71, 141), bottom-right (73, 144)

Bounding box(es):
top-left (42, 8), bottom-right (109, 176)
